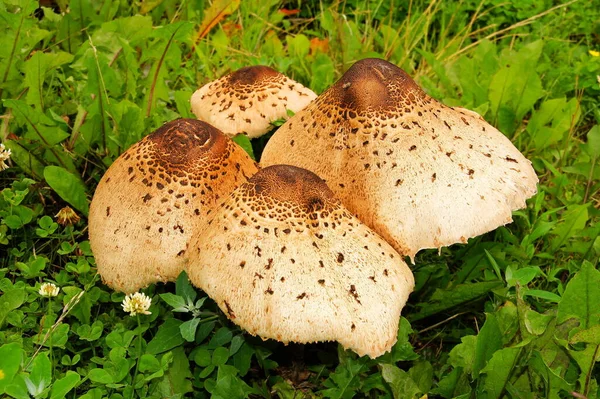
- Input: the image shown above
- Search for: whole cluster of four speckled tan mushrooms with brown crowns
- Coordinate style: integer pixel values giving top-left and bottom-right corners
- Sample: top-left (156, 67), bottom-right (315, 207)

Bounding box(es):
top-left (89, 59), bottom-right (537, 358)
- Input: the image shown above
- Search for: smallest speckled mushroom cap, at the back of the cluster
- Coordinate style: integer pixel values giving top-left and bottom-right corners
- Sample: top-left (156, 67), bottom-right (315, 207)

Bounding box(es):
top-left (191, 65), bottom-right (317, 138)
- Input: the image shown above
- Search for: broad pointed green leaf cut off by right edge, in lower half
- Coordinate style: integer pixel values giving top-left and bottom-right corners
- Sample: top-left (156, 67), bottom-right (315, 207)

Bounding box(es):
top-left (557, 261), bottom-right (600, 329)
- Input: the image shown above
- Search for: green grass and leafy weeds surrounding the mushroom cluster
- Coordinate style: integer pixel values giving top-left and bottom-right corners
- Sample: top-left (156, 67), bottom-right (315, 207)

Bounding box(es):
top-left (0, 0), bottom-right (600, 399)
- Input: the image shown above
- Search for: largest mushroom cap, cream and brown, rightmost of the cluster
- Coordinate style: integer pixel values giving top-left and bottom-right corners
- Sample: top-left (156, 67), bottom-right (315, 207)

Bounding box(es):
top-left (261, 59), bottom-right (538, 258)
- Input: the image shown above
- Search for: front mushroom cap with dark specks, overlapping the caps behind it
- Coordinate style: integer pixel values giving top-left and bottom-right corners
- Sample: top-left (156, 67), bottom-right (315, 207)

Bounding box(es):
top-left (188, 165), bottom-right (414, 357)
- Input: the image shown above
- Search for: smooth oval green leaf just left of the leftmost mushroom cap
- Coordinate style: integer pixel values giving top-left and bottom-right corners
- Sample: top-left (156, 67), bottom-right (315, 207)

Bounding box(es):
top-left (44, 166), bottom-right (90, 216)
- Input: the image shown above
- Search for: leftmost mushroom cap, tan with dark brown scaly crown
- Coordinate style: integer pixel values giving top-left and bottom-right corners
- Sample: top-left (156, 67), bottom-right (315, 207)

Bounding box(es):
top-left (89, 119), bottom-right (257, 293)
